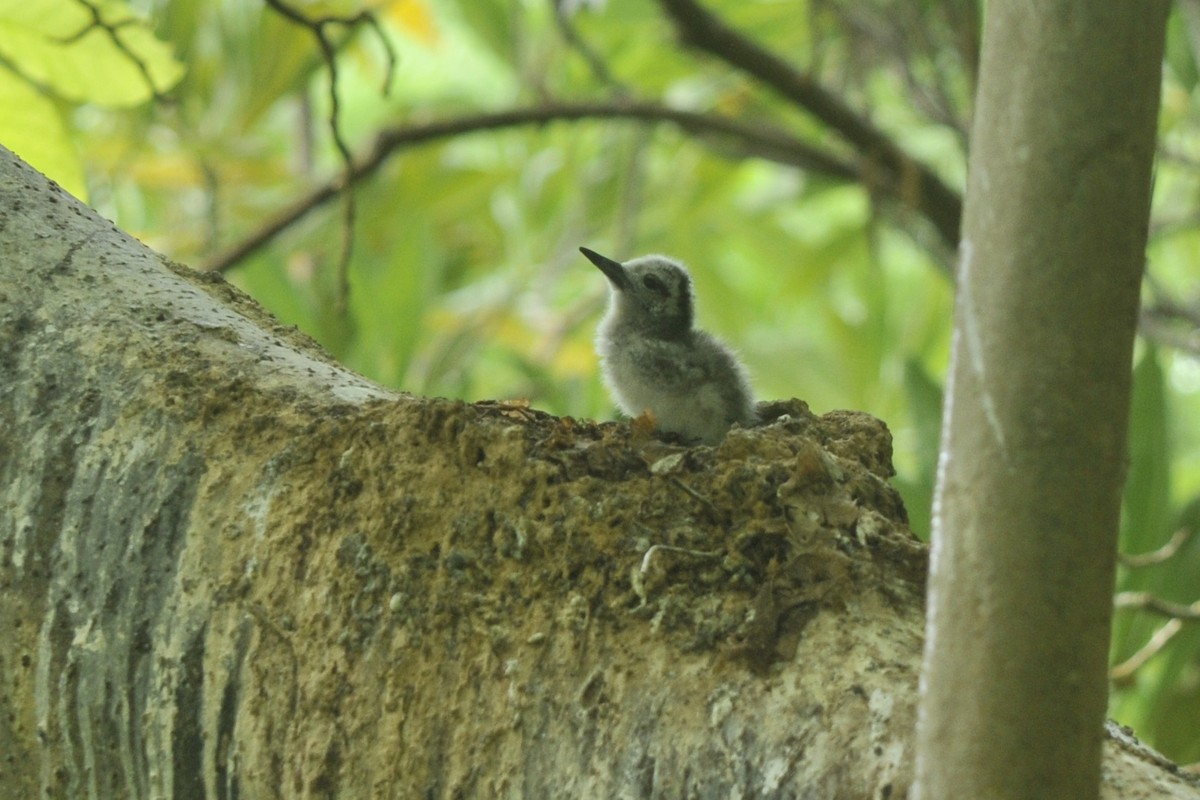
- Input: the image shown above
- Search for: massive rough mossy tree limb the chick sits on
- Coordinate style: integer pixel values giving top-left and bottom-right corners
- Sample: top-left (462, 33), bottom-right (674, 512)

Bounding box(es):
top-left (0, 149), bottom-right (1200, 799)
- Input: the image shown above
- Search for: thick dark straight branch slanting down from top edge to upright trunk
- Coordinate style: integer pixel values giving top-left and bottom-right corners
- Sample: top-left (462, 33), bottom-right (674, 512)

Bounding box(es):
top-left (659, 0), bottom-right (962, 247)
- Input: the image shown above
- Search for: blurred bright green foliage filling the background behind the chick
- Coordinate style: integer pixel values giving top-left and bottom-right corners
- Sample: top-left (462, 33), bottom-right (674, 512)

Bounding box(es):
top-left (7, 0), bottom-right (1200, 762)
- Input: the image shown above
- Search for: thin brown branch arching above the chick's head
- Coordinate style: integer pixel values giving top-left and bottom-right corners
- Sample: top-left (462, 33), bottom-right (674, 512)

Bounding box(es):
top-left (199, 103), bottom-right (862, 272)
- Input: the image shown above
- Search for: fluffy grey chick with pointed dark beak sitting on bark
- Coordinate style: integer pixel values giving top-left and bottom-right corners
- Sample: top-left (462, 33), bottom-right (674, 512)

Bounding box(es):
top-left (580, 247), bottom-right (756, 445)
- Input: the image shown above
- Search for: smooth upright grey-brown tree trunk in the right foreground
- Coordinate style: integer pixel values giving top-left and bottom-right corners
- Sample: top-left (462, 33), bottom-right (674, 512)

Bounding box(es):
top-left (916, 0), bottom-right (1166, 800)
